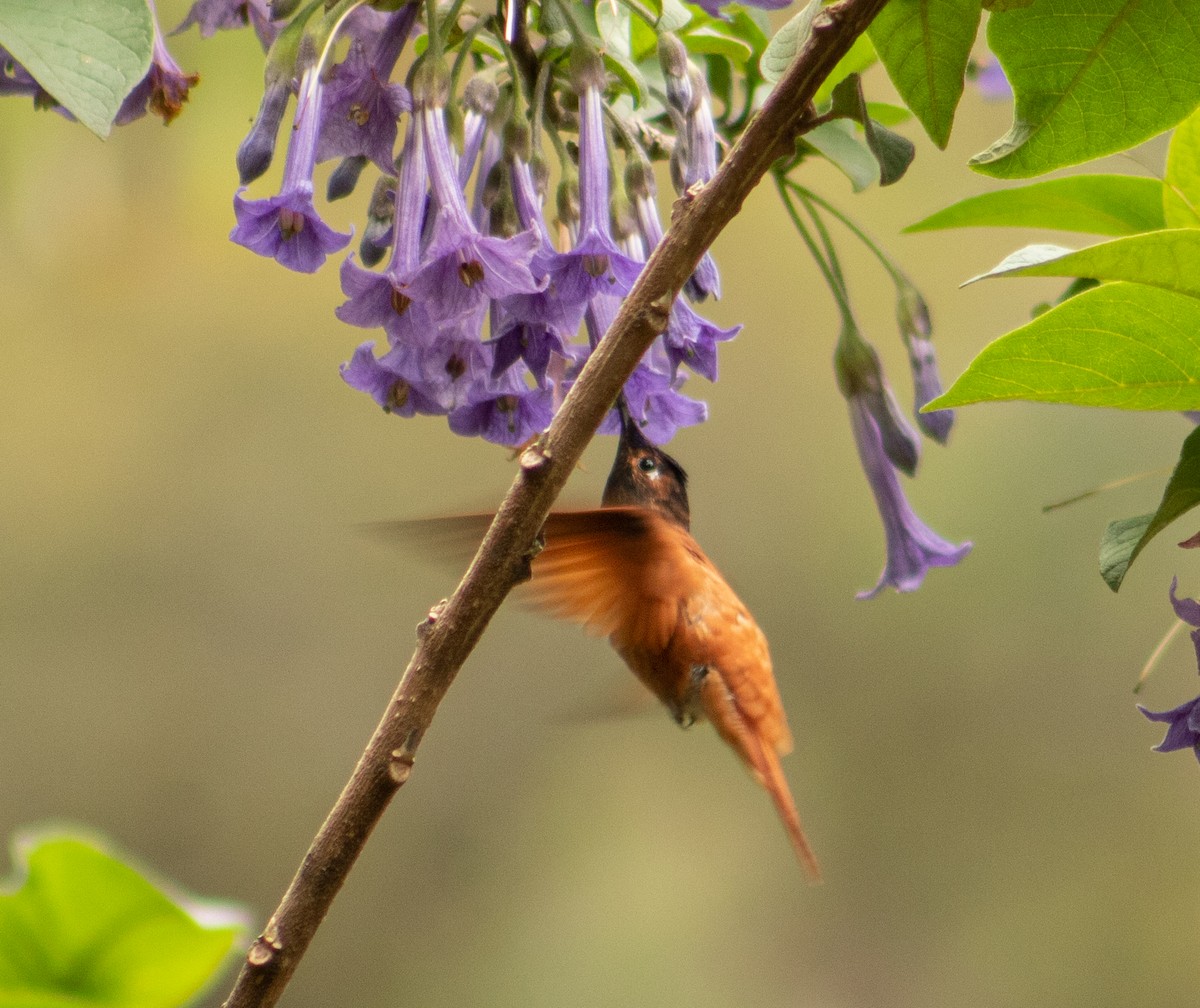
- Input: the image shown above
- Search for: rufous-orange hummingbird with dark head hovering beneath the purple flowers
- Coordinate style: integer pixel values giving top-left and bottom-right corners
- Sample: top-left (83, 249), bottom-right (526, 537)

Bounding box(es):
top-left (380, 401), bottom-right (821, 882)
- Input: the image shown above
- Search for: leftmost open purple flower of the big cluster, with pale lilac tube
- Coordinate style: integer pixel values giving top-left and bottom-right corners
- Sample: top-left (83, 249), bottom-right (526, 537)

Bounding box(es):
top-left (229, 49), bottom-right (350, 272)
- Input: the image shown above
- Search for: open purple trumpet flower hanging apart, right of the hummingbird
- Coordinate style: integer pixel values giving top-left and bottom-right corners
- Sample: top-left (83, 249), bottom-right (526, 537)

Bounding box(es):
top-left (848, 395), bottom-right (971, 599)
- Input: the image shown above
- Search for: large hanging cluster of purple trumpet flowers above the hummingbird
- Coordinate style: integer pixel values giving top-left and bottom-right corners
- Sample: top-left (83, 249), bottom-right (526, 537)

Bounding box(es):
top-left (225, 4), bottom-right (738, 446)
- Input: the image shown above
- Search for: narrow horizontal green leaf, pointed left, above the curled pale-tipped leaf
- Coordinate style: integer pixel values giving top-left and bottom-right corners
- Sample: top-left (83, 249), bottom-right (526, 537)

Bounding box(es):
top-left (905, 175), bottom-right (1164, 235)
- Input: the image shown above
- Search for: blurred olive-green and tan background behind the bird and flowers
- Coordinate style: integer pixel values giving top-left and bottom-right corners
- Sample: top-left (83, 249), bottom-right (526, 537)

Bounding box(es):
top-left (0, 9), bottom-right (1200, 1008)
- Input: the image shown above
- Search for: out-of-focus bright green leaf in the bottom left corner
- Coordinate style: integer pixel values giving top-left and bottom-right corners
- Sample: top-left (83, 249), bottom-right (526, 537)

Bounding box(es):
top-left (0, 834), bottom-right (245, 1008)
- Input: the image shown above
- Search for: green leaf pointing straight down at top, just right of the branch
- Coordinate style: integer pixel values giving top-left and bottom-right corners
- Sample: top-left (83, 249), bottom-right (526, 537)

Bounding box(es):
top-left (868, 0), bottom-right (979, 149)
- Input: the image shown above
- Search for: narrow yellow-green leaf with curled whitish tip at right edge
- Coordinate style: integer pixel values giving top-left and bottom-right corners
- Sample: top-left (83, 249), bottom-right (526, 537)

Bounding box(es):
top-left (968, 228), bottom-right (1200, 298)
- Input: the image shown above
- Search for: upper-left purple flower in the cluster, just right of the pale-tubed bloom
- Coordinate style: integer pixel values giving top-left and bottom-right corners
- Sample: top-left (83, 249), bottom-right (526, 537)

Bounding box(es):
top-left (317, 4), bottom-right (416, 173)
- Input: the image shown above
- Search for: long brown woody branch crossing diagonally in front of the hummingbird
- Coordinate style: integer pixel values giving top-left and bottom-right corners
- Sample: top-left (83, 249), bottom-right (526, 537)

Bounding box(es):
top-left (224, 0), bottom-right (887, 1008)
